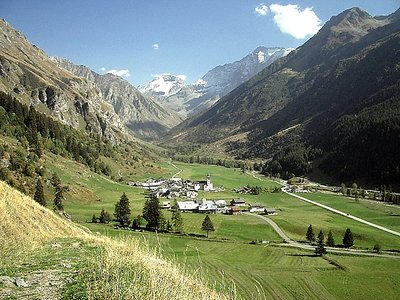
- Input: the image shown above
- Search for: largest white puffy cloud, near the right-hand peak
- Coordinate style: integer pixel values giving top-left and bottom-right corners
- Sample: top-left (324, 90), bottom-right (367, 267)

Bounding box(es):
top-left (269, 4), bottom-right (321, 39)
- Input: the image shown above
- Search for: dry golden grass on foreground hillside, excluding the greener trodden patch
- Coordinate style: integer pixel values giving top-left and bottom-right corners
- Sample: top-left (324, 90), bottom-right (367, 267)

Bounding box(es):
top-left (0, 181), bottom-right (235, 300)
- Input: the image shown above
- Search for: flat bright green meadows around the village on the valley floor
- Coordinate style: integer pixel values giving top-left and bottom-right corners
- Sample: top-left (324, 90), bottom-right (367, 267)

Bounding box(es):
top-left (49, 158), bottom-right (400, 299)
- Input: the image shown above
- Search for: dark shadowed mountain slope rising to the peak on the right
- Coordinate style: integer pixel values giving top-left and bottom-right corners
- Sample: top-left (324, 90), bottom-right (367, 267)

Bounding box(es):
top-left (167, 8), bottom-right (400, 180)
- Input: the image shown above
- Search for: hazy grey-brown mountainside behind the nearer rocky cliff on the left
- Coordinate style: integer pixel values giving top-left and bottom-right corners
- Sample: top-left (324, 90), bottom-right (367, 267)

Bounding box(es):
top-left (52, 57), bottom-right (182, 139)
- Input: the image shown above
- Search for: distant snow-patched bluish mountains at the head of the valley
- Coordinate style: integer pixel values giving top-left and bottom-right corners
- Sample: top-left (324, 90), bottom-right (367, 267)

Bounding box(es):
top-left (139, 47), bottom-right (293, 116)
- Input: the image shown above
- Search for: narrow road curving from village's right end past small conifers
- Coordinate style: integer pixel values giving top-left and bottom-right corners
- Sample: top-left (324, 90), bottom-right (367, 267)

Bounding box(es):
top-left (245, 213), bottom-right (400, 259)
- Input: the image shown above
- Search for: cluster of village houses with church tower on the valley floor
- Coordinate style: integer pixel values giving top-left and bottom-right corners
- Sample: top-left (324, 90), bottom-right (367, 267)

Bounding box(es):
top-left (128, 174), bottom-right (276, 215)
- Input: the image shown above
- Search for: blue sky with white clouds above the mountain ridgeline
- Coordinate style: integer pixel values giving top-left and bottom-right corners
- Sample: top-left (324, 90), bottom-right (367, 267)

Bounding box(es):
top-left (0, 0), bottom-right (399, 85)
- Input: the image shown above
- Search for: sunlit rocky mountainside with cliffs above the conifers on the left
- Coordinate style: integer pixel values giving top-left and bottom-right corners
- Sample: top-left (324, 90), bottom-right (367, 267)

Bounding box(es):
top-left (0, 20), bottom-right (126, 141)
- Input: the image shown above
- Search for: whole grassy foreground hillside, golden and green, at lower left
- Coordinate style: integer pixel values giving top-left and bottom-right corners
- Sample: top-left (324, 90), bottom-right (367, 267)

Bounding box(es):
top-left (0, 182), bottom-right (233, 299)
